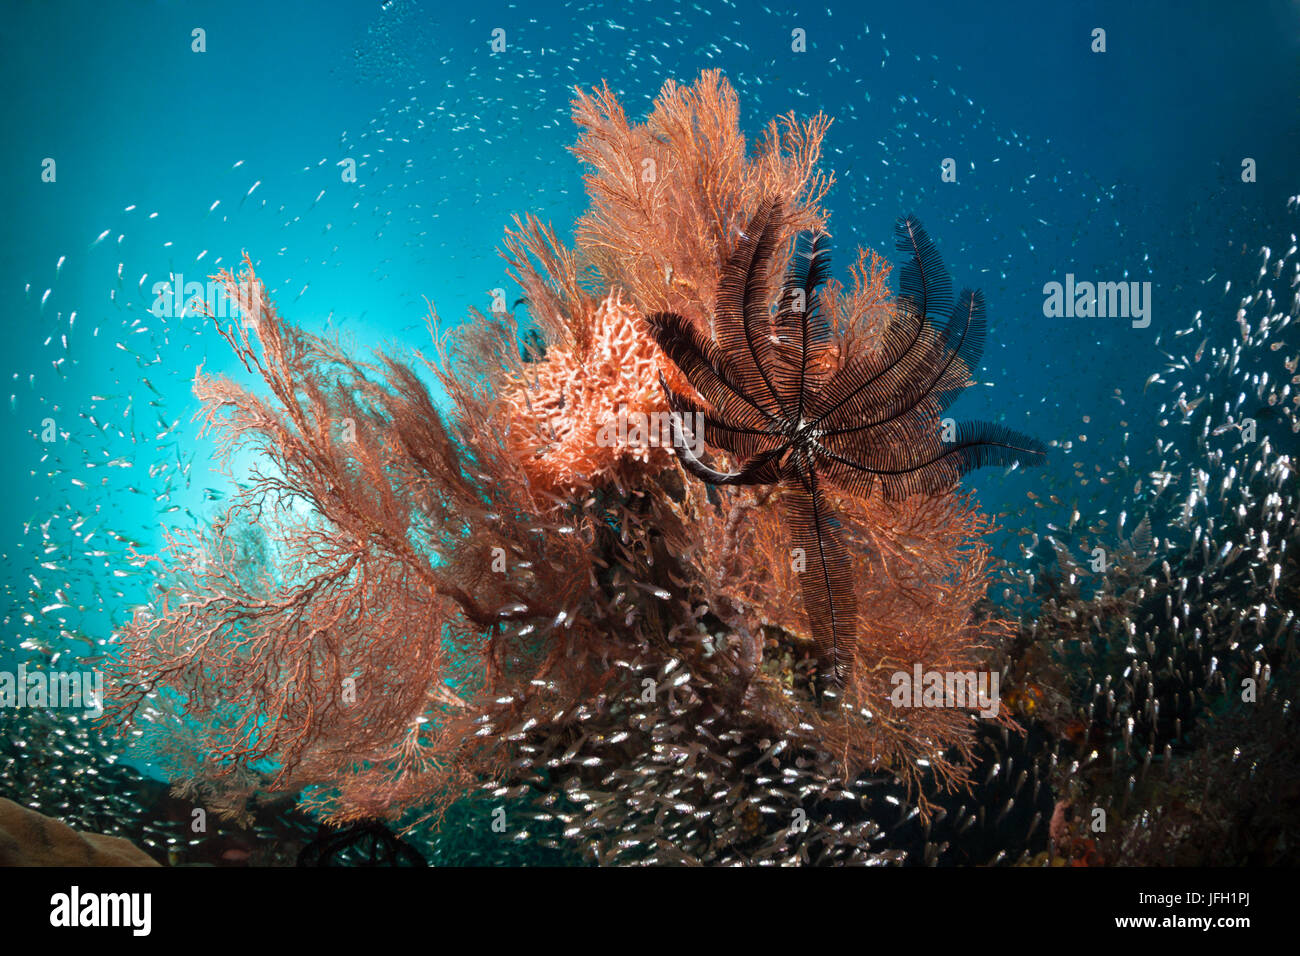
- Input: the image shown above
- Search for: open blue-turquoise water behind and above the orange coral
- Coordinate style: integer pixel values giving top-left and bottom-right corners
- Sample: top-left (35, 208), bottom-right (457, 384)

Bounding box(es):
top-left (0, 0), bottom-right (1300, 868)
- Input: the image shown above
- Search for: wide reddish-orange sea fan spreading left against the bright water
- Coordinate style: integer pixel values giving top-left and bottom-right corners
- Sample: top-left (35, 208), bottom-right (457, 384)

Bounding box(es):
top-left (111, 260), bottom-right (589, 819)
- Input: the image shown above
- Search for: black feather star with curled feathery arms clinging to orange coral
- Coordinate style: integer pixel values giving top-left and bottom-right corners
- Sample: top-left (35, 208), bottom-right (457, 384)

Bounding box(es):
top-left (647, 199), bottom-right (1045, 688)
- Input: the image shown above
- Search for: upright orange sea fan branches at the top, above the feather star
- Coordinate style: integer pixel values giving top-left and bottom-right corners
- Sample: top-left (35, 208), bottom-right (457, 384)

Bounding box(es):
top-left (506, 70), bottom-right (833, 348)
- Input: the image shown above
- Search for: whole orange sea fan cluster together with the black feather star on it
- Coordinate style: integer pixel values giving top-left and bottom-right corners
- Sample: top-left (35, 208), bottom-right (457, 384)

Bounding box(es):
top-left (111, 72), bottom-right (1041, 861)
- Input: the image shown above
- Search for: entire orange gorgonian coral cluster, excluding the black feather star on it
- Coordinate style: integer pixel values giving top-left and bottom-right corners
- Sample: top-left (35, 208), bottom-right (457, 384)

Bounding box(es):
top-left (111, 72), bottom-right (1029, 837)
